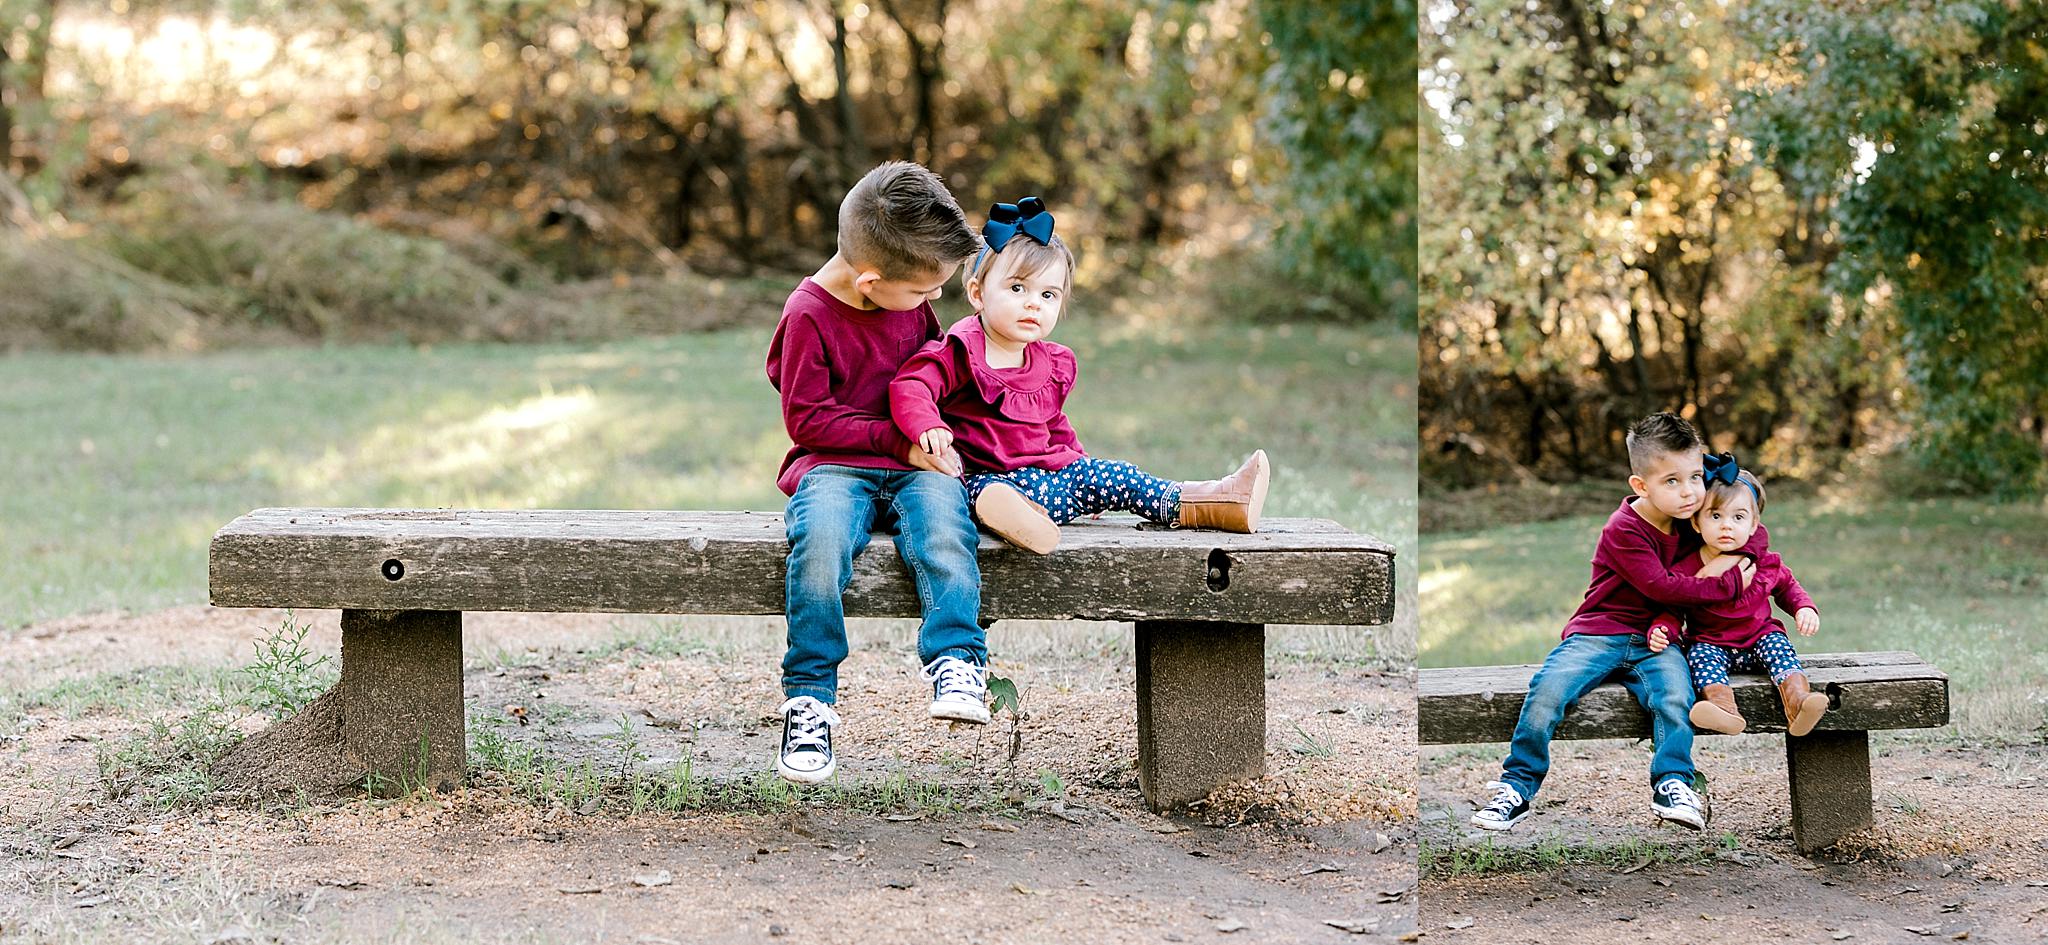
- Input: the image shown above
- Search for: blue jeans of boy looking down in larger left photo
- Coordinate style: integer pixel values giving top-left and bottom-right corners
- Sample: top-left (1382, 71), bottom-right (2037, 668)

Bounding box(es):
top-left (782, 465), bottom-right (989, 705)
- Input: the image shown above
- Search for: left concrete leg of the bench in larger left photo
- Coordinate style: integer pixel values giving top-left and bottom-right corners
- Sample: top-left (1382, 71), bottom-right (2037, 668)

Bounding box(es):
top-left (346, 611), bottom-right (467, 793)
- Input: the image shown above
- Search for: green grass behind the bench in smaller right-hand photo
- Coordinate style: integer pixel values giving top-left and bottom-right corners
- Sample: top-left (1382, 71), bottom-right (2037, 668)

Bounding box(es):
top-left (1419, 496), bottom-right (2048, 742)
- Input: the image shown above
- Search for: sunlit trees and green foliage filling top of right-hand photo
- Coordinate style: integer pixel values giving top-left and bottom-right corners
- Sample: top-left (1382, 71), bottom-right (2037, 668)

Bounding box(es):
top-left (1419, 0), bottom-right (2048, 494)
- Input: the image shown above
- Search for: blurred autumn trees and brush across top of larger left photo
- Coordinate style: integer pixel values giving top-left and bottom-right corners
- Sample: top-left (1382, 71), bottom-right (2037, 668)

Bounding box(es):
top-left (0, 0), bottom-right (1415, 348)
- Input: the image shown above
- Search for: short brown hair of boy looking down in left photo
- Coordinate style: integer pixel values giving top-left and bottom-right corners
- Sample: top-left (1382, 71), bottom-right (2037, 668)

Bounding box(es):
top-left (840, 160), bottom-right (981, 279)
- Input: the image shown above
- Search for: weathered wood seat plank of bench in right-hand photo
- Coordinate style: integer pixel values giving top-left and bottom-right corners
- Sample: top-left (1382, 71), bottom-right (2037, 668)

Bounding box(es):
top-left (1415, 652), bottom-right (1948, 744)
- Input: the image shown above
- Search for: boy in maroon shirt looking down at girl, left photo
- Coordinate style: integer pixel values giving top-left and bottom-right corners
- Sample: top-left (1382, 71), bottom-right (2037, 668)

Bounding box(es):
top-left (768, 162), bottom-right (989, 783)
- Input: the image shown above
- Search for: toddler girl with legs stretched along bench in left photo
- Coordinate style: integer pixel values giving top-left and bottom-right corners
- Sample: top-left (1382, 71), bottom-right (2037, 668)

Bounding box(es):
top-left (889, 197), bottom-right (1270, 553)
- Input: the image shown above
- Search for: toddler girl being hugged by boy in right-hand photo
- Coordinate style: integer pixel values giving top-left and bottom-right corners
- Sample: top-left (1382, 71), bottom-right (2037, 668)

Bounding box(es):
top-left (1649, 453), bottom-right (1827, 736)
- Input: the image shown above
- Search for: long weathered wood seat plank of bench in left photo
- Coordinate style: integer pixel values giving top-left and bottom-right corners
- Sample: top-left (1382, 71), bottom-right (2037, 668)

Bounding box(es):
top-left (209, 508), bottom-right (1395, 625)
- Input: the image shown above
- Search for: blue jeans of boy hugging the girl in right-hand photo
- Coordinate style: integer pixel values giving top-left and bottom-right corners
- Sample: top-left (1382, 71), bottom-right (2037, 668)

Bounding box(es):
top-left (1501, 633), bottom-right (1692, 797)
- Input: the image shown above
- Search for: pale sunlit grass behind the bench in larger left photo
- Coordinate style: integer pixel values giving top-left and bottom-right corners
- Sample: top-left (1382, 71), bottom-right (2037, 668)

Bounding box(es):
top-left (0, 309), bottom-right (1415, 662)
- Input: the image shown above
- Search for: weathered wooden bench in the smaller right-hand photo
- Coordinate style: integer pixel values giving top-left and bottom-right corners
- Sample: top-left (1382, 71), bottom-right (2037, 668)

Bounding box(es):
top-left (1415, 652), bottom-right (1948, 853)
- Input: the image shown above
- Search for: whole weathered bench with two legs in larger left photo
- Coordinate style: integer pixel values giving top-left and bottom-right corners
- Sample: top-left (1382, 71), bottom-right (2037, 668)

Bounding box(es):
top-left (209, 508), bottom-right (1395, 808)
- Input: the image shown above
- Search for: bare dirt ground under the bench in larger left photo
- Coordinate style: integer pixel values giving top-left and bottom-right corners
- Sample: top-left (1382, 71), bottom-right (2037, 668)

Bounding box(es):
top-left (0, 607), bottom-right (1415, 945)
